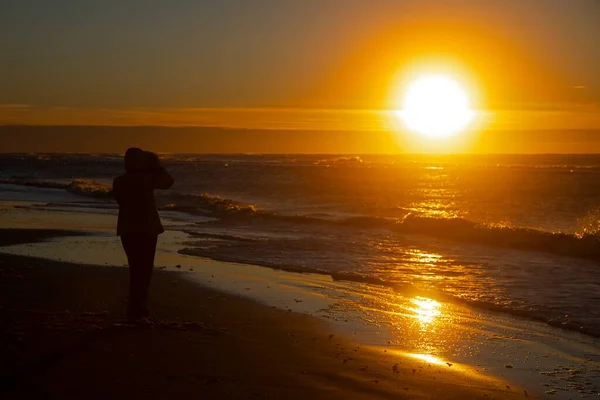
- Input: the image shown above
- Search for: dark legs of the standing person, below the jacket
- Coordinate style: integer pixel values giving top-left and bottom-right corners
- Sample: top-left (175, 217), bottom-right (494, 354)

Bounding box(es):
top-left (121, 235), bottom-right (146, 319)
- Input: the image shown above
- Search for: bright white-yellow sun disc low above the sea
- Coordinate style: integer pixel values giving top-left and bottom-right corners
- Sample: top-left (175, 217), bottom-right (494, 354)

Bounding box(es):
top-left (399, 75), bottom-right (475, 138)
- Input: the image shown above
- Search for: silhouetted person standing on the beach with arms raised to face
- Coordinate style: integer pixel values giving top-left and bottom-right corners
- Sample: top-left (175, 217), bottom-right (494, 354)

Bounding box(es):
top-left (113, 148), bottom-right (173, 320)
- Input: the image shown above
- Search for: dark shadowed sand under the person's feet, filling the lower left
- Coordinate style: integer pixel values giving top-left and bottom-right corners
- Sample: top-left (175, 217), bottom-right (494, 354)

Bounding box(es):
top-left (0, 230), bottom-right (520, 399)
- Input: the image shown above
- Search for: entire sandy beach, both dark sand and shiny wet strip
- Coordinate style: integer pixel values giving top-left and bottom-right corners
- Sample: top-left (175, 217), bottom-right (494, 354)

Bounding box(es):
top-left (0, 212), bottom-right (600, 399)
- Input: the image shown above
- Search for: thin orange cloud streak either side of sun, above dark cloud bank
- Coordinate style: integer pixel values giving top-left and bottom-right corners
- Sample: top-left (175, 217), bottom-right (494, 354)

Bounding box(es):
top-left (0, 104), bottom-right (600, 131)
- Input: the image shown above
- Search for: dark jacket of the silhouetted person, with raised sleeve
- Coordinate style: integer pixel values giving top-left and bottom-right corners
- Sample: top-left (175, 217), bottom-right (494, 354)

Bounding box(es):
top-left (113, 167), bottom-right (174, 236)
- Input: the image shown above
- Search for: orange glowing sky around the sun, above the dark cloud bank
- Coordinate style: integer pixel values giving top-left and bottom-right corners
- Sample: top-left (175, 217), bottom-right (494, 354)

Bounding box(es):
top-left (0, 0), bottom-right (600, 151)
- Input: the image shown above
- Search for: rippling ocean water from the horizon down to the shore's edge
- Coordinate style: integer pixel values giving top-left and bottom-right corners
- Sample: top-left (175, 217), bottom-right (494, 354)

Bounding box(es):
top-left (0, 154), bottom-right (600, 337)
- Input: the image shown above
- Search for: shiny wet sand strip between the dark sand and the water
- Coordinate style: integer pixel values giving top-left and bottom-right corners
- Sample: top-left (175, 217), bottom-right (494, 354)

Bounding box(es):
top-left (0, 208), bottom-right (600, 399)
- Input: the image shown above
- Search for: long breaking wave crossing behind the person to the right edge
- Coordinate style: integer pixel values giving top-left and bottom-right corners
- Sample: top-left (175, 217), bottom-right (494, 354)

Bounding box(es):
top-left (0, 178), bottom-right (600, 260)
